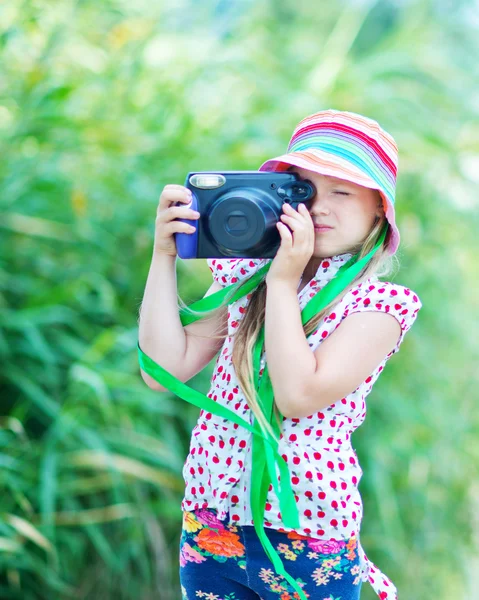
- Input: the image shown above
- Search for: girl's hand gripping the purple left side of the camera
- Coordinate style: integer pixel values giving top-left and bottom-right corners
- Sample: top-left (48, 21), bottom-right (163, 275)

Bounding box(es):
top-left (154, 184), bottom-right (200, 256)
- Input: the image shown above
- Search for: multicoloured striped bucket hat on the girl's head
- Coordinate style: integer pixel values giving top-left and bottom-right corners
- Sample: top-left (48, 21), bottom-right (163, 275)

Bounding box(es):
top-left (259, 109), bottom-right (400, 254)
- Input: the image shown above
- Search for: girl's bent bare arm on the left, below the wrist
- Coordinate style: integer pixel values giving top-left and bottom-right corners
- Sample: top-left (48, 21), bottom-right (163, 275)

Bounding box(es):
top-left (139, 253), bottom-right (227, 391)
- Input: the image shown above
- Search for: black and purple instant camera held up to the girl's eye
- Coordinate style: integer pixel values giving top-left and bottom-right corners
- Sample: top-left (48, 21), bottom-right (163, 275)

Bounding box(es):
top-left (175, 171), bottom-right (316, 258)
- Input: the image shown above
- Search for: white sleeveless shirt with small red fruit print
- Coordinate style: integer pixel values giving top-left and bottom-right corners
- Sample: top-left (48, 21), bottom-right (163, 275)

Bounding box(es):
top-left (181, 254), bottom-right (421, 600)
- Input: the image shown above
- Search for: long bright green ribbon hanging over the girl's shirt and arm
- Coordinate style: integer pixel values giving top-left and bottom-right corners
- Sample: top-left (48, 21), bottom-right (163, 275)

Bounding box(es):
top-left (138, 228), bottom-right (387, 600)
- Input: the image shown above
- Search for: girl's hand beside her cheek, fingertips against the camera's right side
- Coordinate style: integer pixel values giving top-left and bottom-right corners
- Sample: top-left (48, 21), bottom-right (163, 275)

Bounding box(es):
top-left (266, 203), bottom-right (315, 288)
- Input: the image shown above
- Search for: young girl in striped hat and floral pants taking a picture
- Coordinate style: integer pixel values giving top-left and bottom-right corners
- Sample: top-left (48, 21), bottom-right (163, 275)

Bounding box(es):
top-left (139, 110), bottom-right (421, 600)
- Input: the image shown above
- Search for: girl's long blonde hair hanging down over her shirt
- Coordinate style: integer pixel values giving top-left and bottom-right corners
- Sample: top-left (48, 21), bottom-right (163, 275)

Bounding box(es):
top-left (180, 204), bottom-right (394, 441)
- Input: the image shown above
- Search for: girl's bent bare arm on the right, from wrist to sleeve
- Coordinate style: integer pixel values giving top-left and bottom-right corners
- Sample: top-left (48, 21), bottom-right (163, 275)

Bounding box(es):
top-left (265, 281), bottom-right (401, 418)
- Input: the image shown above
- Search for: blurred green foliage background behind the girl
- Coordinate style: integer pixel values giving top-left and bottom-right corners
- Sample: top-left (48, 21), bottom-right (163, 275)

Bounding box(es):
top-left (0, 0), bottom-right (479, 600)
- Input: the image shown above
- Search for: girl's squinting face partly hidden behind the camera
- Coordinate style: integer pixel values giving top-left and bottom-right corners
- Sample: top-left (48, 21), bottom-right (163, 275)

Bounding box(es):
top-left (288, 167), bottom-right (383, 258)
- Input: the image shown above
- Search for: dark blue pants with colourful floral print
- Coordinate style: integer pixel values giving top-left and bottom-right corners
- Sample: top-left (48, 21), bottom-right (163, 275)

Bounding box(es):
top-left (180, 508), bottom-right (361, 600)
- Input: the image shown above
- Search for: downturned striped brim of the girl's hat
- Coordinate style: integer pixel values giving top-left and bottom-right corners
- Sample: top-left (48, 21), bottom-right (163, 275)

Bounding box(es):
top-left (258, 148), bottom-right (400, 254)
